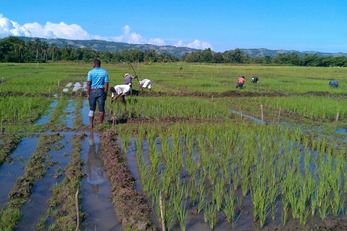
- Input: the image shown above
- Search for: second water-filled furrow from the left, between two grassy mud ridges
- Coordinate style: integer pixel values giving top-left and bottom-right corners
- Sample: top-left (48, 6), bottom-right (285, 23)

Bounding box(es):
top-left (15, 135), bottom-right (72, 231)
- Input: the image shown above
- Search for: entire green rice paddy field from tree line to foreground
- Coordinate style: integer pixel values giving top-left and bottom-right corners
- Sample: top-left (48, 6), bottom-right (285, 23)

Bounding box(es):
top-left (0, 63), bottom-right (347, 231)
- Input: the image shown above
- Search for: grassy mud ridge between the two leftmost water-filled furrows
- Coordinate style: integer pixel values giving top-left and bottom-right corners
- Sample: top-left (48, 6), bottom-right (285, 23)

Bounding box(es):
top-left (0, 135), bottom-right (63, 230)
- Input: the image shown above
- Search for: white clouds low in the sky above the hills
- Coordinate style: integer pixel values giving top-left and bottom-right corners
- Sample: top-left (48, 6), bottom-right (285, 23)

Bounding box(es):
top-left (0, 14), bottom-right (212, 49)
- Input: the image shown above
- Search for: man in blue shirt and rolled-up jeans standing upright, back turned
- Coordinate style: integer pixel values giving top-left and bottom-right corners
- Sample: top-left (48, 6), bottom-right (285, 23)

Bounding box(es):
top-left (87, 59), bottom-right (109, 129)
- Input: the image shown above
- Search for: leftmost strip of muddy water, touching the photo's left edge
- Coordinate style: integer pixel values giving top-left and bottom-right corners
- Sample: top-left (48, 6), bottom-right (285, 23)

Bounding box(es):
top-left (0, 137), bottom-right (38, 209)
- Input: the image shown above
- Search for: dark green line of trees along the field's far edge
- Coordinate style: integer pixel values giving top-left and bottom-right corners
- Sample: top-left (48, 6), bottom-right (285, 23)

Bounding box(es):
top-left (0, 36), bottom-right (347, 67)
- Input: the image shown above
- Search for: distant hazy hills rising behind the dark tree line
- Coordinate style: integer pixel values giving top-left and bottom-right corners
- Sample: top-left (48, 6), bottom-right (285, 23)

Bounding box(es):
top-left (19, 37), bottom-right (347, 58)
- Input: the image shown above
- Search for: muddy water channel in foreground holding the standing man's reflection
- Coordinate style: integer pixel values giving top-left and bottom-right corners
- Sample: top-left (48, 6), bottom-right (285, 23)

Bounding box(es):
top-left (80, 133), bottom-right (121, 230)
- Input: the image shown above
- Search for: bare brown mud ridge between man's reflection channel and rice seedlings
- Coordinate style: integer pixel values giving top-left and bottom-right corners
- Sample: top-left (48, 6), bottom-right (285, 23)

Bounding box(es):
top-left (100, 132), bottom-right (156, 230)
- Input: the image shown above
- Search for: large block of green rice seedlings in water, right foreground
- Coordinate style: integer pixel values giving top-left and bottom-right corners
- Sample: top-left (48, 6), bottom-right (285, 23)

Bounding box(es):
top-left (120, 123), bottom-right (346, 229)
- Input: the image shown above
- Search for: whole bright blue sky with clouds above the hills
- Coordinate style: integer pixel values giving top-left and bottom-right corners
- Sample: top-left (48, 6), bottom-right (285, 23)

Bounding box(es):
top-left (0, 0), bottom-right (347, 53)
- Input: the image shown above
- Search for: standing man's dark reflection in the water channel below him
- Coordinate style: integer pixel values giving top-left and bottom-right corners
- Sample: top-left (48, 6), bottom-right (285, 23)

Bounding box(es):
top-left (86, 132), bottom-right (106, 192)
